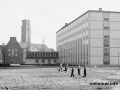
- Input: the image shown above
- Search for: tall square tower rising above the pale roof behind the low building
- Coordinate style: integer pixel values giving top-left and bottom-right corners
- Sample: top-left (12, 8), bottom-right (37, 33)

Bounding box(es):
top-left (21, 19), bottom-right (31, 49)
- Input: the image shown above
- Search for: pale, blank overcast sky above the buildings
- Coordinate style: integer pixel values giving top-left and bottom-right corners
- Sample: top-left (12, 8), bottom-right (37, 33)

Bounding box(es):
top-left (0, 0), bottom-right (120, 50)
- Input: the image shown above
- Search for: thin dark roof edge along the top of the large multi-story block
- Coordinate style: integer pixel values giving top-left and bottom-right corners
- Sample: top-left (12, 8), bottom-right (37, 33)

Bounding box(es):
top-left (56, 10), bottom-right (120, 33)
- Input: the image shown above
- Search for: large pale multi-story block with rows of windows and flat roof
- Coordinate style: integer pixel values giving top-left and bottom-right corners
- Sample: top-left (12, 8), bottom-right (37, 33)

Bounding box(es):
top-left (56, 8), bottom-right (120, 65)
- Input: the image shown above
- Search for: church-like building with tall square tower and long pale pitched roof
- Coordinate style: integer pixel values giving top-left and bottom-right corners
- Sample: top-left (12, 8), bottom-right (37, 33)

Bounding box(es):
top-left (19, 19), bottom-right (50, 52)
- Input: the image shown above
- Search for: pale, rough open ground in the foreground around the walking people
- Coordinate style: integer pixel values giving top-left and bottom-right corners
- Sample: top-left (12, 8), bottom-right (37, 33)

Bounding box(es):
top-left (0, 67), bottom-right (120, 90)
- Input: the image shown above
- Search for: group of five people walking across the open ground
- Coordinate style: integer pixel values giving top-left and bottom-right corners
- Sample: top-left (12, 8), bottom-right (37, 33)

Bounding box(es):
top-left (58, 63), bottom-right (86, 77)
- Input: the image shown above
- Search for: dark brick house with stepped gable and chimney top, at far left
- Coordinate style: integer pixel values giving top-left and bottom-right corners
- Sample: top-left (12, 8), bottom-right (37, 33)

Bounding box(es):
top-left (2, 37), bottom-right (24, 64)
